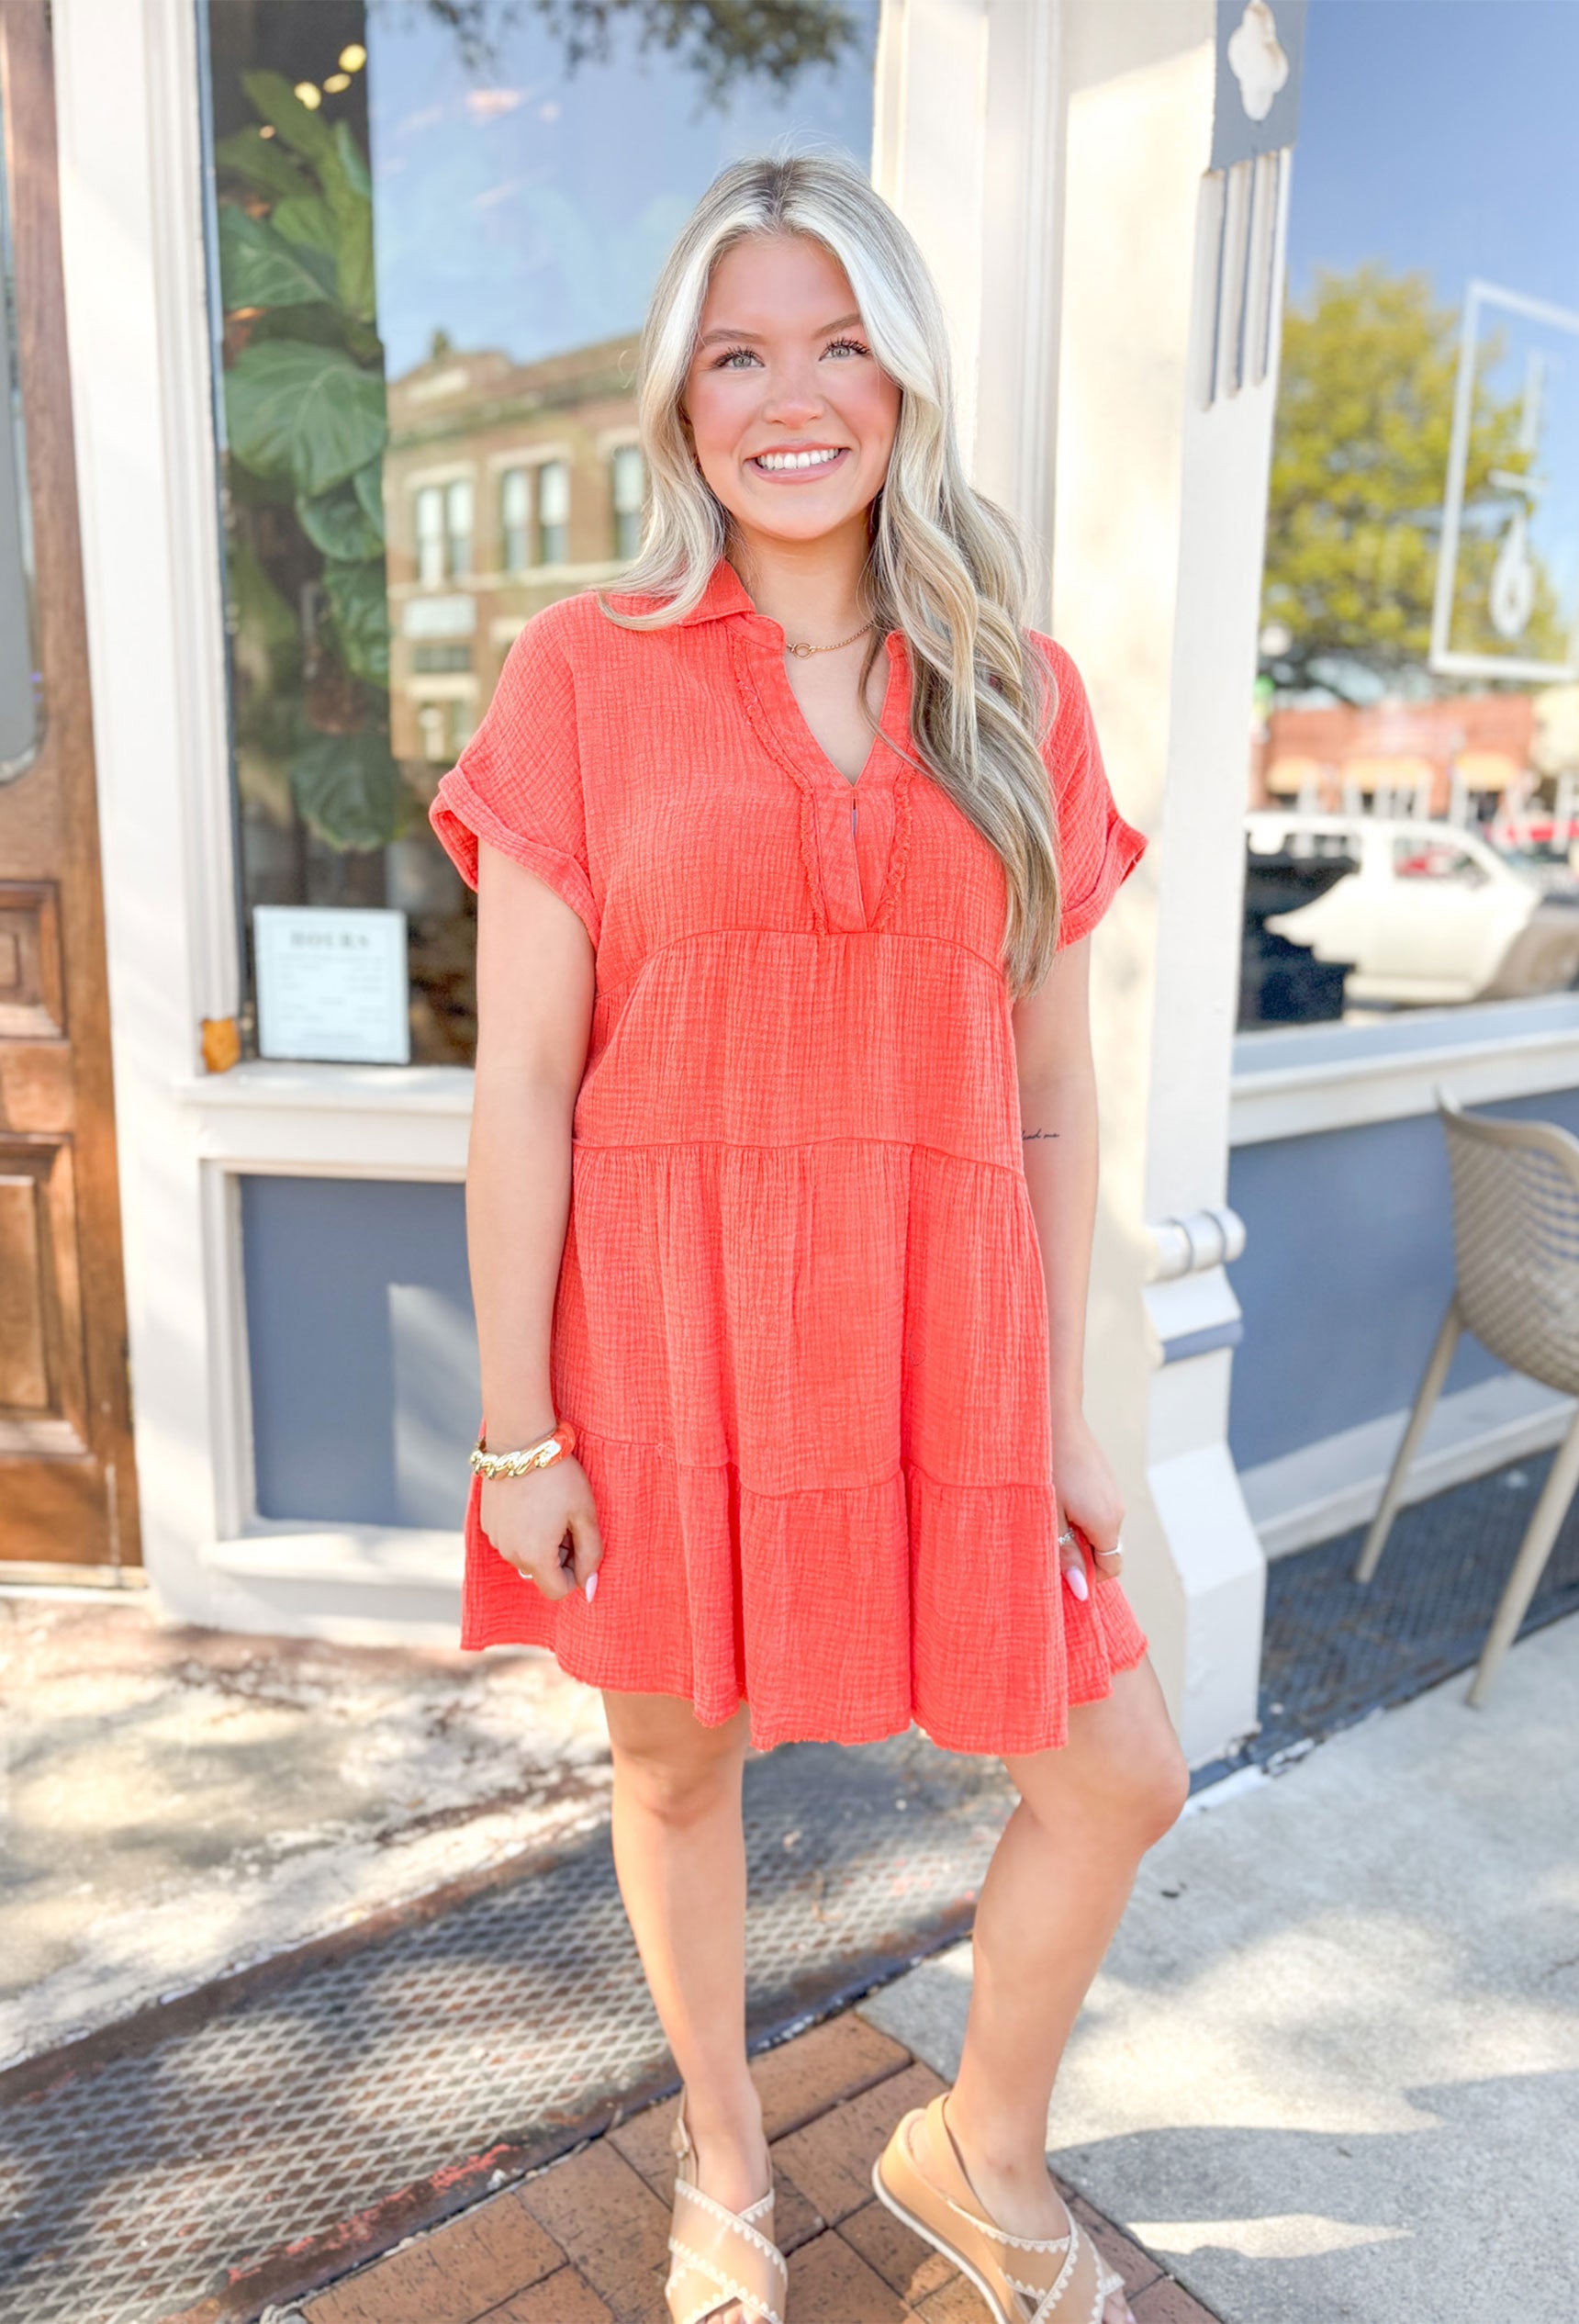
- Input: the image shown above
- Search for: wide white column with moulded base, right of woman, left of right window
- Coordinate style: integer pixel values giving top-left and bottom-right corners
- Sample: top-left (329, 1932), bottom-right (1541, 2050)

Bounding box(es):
top-left (1052, 0), bottom-right (1286, 1764)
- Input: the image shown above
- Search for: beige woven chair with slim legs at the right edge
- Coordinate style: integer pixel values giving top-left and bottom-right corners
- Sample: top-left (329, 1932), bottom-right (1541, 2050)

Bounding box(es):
top-left (1354, 1090), bottom-right (1579, 1703)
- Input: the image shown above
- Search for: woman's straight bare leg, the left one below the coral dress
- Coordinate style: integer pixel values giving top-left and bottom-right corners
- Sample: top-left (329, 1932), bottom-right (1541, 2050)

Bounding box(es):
top-left (604, 1692), bottom-right (771, 2324)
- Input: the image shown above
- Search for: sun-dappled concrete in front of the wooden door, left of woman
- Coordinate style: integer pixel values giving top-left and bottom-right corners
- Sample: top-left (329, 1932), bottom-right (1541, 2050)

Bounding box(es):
top-left (0, 1589), bottom-right (609, 2066)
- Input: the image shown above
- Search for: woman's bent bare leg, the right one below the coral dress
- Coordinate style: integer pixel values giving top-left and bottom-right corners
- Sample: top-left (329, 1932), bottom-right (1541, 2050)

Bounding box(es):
top-left (947, 1662), bottom-right (1189, 2324)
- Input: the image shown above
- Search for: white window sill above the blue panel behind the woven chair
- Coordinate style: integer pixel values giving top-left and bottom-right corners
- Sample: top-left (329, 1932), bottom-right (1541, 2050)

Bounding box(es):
top-left (1228, 993), bottom-right (1579, 1146)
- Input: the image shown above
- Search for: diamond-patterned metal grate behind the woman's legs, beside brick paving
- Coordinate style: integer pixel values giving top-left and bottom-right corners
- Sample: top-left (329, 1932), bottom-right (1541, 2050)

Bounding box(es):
top-left (0, 1736), bottom-right (1010, 2324)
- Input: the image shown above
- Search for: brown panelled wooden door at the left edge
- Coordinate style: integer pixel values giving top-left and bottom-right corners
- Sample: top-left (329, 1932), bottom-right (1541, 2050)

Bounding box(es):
top-left (0, 0), bottom-right (137, 1566)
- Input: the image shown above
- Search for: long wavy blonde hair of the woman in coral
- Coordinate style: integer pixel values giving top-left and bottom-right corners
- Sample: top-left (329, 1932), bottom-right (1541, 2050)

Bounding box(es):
top-left (599, 156), bottom-right (1058, 997)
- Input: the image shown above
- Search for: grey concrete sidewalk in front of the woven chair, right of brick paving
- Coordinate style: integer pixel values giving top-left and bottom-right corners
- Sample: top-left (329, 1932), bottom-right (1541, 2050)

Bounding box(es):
top-left (861, 1620), bottom-right (1579, 2324)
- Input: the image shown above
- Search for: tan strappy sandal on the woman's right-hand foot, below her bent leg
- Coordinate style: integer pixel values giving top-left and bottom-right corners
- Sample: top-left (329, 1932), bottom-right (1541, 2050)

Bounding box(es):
top-left (871, 2092), bottom-right (1124, 2324)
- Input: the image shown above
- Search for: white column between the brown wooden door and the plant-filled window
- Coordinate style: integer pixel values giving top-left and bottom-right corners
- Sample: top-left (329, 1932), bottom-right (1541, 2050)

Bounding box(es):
top-left (53, 0), bottom-right (237, 1611)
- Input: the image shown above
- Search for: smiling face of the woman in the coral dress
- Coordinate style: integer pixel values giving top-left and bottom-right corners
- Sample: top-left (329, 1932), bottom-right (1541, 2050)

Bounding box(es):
top-left (685, 235), bottom-right (899, 544)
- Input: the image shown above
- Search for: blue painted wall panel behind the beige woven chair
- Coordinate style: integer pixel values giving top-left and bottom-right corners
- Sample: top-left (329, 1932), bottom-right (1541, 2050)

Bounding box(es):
top-left (1228, 1090), bottom-right (1579, 1469)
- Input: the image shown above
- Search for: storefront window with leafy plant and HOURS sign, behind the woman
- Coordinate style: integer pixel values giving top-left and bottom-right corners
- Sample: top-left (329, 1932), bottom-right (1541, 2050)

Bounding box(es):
top-left (200, 0), bottom-right (878, 1062)
